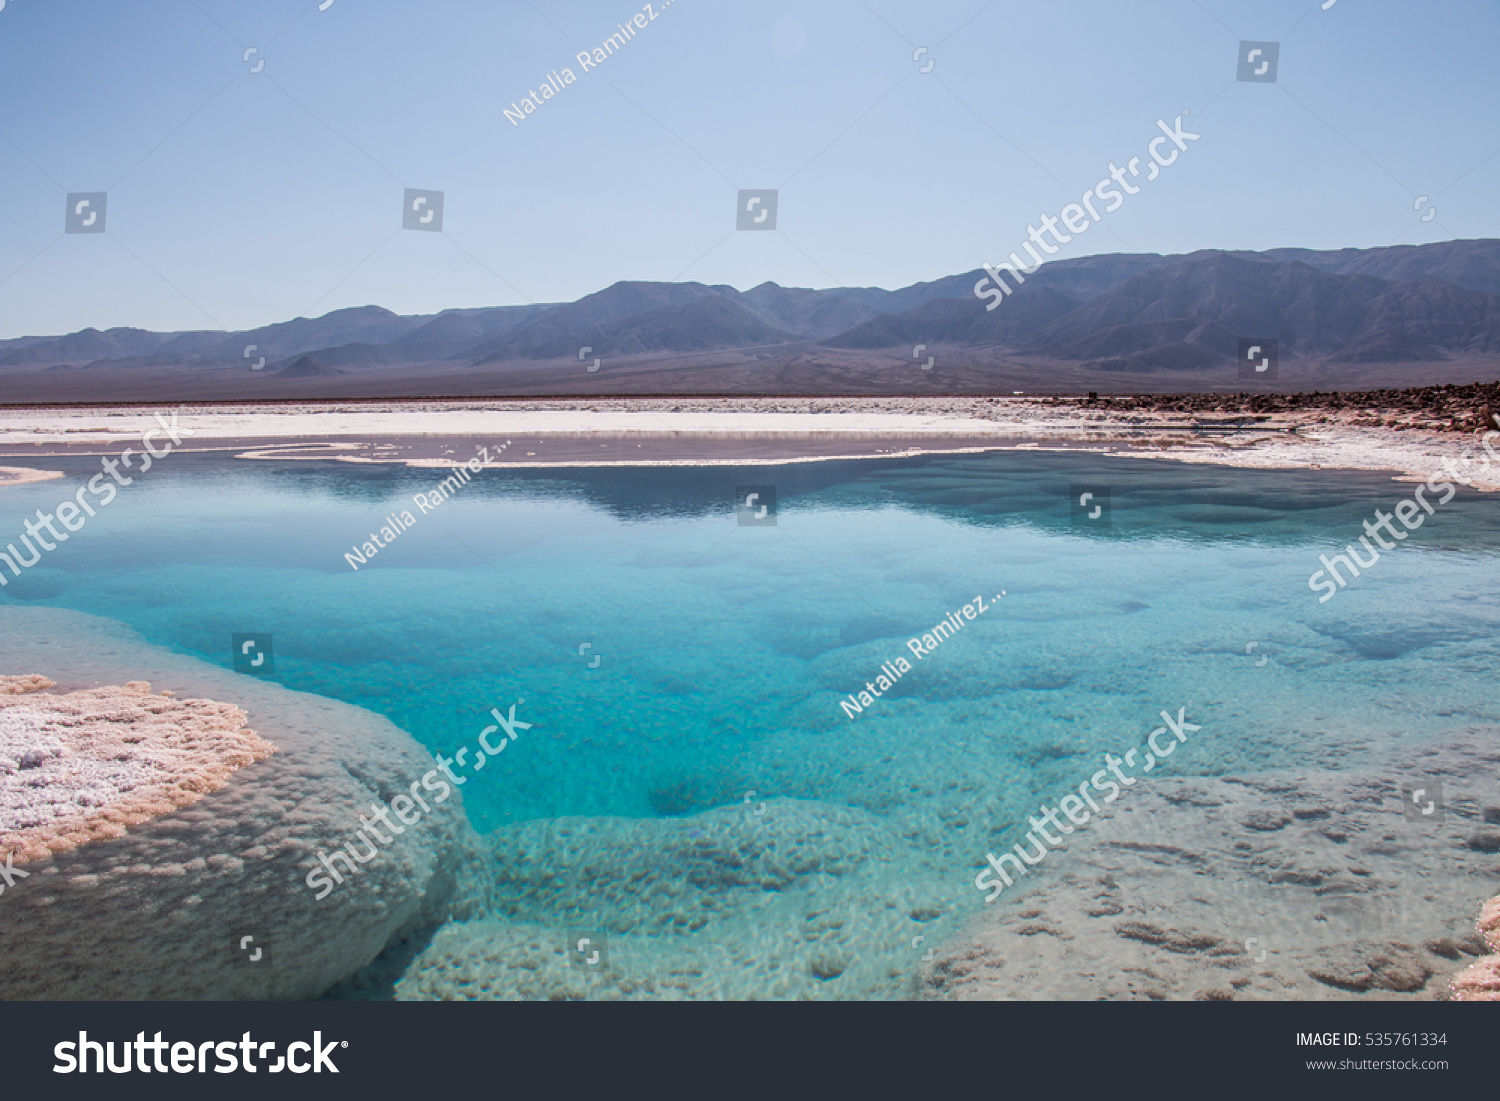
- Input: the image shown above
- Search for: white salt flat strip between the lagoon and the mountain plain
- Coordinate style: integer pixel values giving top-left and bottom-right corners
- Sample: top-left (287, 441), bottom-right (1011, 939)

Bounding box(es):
top-left (0, 398), bottom-right (1500, 489)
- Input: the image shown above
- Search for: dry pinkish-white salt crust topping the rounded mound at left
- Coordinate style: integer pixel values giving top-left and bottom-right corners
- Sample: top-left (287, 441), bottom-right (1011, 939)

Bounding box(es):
top-left (0, 675), bottom-right (276, 864)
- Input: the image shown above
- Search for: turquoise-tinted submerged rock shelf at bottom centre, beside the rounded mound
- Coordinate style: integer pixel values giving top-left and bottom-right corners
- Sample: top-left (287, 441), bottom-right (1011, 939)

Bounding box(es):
top-left (395, 800), bottom-right (956, 1001)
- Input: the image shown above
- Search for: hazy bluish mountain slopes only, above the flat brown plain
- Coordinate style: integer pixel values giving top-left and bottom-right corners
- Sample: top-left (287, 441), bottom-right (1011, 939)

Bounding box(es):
top-left (0, 240), bottom-right (1500, 378)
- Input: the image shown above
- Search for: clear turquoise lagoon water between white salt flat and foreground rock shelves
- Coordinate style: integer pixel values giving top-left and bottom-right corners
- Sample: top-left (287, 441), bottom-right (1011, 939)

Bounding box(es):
top-left (0, 452), bottom-right (1500, 1002)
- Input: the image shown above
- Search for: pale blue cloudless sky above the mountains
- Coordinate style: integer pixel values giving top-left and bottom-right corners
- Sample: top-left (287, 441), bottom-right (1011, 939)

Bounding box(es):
top-left (0, 0), bottom-right (1500, 336)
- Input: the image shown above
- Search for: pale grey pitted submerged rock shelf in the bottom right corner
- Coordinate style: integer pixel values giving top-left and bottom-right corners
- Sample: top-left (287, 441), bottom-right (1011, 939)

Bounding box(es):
top-left (921, 728), bottom-right (1500, 1001)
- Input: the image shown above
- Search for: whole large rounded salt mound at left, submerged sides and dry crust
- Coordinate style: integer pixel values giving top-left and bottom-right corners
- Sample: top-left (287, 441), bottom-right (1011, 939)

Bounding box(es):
top-left (0, 605), bottom-right (485, 1002)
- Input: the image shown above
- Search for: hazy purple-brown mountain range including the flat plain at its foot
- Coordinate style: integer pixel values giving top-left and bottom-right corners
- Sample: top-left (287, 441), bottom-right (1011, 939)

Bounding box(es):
top-left (0, 240), bottom-right (1500, 404)
